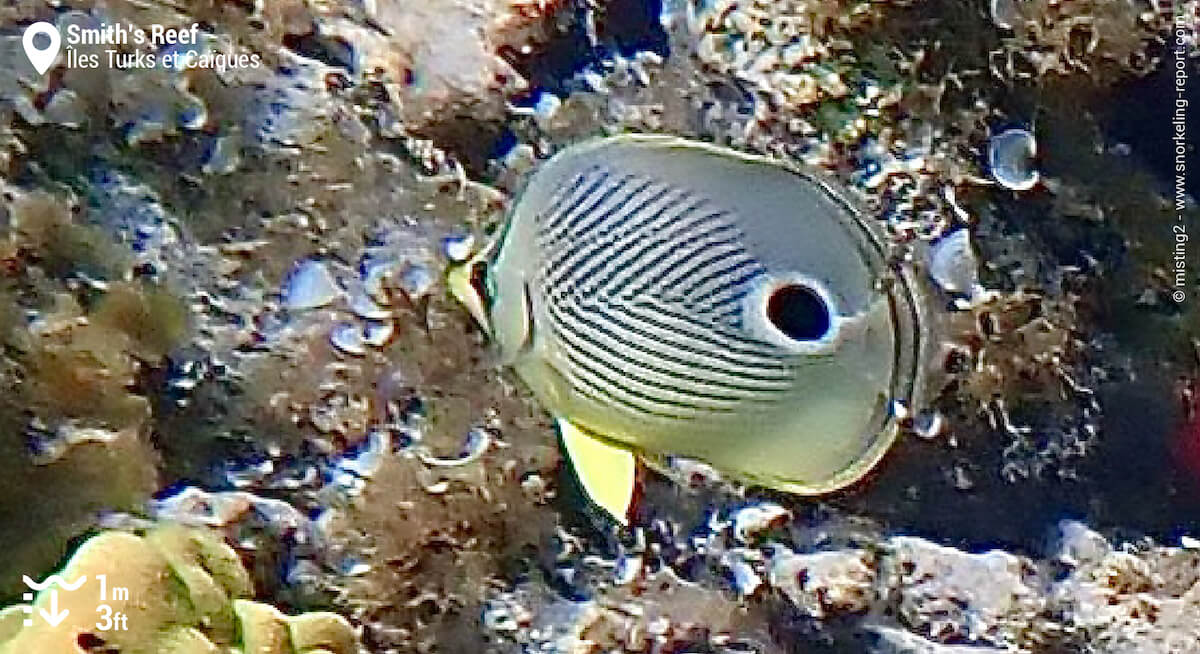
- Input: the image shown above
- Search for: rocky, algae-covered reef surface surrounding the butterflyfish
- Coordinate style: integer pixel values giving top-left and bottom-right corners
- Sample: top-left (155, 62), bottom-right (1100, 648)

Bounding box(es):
top-left (0, 0), bottom-right (1200, 654)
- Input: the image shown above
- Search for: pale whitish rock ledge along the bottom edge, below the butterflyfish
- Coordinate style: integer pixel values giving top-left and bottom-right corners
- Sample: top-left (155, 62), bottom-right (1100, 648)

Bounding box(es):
top-left (484, 521), bottom-right (1200, 654)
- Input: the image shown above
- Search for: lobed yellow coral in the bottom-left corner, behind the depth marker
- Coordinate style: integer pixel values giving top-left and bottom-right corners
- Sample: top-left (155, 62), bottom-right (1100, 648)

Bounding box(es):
top-left (0, 524), bottom-right (359, 654)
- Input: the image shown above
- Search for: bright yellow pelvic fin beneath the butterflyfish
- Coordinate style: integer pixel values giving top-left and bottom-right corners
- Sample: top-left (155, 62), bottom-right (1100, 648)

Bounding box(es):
top-left (556, 418), bottom-right (637, 526)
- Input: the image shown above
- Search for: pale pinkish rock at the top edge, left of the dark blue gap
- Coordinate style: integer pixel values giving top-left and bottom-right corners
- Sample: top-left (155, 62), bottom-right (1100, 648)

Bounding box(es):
top-left (292, 0), bottom-right (566, 159)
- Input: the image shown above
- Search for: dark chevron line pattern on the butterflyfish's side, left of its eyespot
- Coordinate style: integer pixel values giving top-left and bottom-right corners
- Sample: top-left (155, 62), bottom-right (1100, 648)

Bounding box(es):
top-left (533, 166), bottom-right (796, 420)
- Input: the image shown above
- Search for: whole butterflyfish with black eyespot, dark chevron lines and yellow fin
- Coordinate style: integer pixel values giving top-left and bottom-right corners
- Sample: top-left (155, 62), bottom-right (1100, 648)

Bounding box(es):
top-left (448, 134), bottom-right (928, 524)
